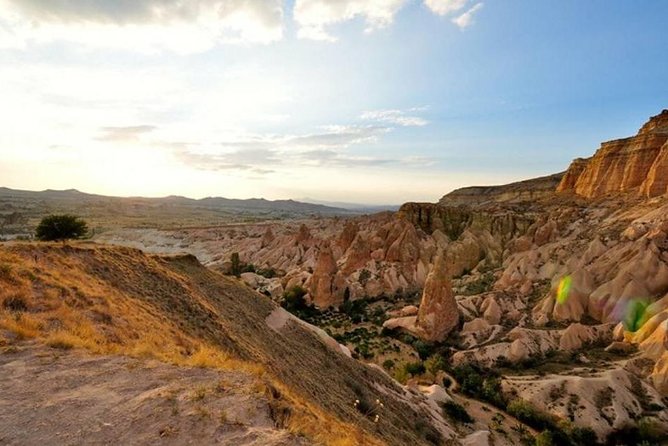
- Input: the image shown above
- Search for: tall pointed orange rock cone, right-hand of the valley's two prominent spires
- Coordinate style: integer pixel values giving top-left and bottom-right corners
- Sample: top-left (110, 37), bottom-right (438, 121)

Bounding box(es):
top-left (416, 254), bottom-right (459, 342)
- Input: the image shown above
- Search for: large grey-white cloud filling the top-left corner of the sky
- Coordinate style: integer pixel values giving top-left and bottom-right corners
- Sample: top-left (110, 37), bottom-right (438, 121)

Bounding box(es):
top-left (0, 0), bottom-right (283, 53)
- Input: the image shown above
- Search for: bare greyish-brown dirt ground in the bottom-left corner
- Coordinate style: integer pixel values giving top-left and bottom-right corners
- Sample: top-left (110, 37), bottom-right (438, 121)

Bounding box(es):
top-left (0, 343), bottom-right (307, 446)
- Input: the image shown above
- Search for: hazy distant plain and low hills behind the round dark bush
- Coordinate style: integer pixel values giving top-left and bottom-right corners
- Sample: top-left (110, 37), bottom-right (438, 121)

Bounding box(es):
top-left (0, 187), bottom-right (363, 236)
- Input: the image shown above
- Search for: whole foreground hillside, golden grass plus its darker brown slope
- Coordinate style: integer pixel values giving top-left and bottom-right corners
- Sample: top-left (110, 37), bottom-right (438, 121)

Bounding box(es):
top-left (0, 243), bottom-right (448, 445)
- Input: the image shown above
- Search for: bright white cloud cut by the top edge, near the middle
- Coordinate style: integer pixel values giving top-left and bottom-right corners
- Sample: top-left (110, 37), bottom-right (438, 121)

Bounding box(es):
top-left (294, 0), bottom-right (407, 41)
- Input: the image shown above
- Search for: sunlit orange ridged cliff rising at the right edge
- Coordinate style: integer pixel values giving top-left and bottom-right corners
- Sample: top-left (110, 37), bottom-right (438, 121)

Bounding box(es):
top-left (557, 110), bottom-right (668, 198)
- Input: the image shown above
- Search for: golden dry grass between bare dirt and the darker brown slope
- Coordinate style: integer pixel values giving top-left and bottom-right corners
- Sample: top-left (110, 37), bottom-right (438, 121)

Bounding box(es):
top-left (0, 244), bottom-right (383, 446)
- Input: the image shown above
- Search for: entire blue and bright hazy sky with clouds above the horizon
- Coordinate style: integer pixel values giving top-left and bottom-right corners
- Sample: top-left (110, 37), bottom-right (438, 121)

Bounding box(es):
top-left (0, 0), bottom-right (668, 204)
